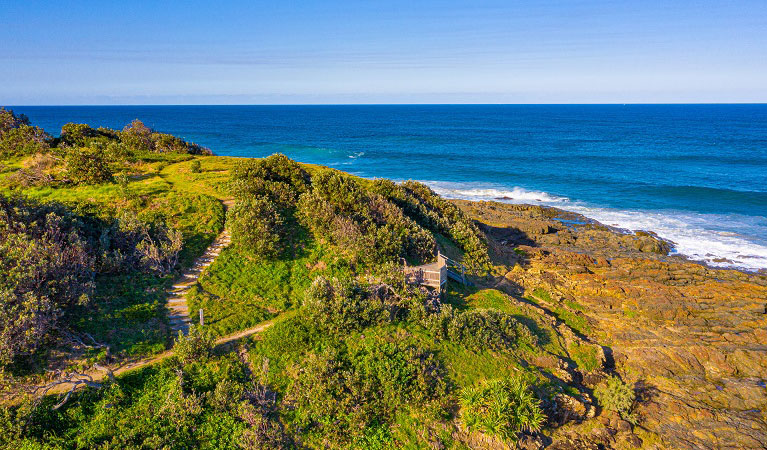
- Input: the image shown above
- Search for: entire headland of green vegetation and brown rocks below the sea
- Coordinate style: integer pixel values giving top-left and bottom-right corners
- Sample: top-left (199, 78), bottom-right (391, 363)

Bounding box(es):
top-left (0, 110), bottom-right (767, 448)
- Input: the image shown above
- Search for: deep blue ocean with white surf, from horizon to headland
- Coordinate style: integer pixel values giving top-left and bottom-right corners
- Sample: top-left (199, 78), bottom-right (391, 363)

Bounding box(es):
top-left (13, 105), bottom-right (767, 269)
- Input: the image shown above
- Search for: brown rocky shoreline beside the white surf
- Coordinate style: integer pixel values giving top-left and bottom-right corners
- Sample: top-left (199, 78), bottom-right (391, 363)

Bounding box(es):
top-left (454, 200), bottom-right (767, 448)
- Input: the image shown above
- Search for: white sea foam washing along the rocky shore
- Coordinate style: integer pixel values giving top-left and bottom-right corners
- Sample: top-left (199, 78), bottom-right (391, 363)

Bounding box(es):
top-left (424, 181), bottom-right (767, 271)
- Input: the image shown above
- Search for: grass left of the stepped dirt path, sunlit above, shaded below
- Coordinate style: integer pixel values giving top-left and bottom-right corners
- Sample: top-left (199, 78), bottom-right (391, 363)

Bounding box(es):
top-left (2, 153), bottom-right (233, 356)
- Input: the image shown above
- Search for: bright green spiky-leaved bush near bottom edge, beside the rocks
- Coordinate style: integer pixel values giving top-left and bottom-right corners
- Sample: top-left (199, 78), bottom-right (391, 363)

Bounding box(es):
top-left (460, 377), bottom-right (546, 442)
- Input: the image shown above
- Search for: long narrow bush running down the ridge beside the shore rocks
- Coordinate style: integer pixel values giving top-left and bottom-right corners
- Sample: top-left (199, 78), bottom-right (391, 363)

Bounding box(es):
top-left (373, 179), bottom-right (490, 275)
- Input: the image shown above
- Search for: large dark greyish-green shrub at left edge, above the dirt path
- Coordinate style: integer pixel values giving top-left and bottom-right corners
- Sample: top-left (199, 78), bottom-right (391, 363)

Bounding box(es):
top-left (0, 196), bottom-right (95, 365)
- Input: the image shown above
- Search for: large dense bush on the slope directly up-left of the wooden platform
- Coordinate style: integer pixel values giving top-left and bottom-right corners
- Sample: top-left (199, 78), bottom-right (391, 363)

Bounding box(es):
top-left (298, 170), bottom-right (436, 263)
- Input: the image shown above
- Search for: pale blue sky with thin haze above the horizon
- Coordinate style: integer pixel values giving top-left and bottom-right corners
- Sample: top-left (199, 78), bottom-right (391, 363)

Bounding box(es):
top-left (0, 0), bottom-right (767, 105)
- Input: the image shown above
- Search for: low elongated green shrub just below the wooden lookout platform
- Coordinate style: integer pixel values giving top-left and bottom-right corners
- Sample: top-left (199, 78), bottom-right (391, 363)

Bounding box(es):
top-left (424, 305), bottom-right (538, 351)
